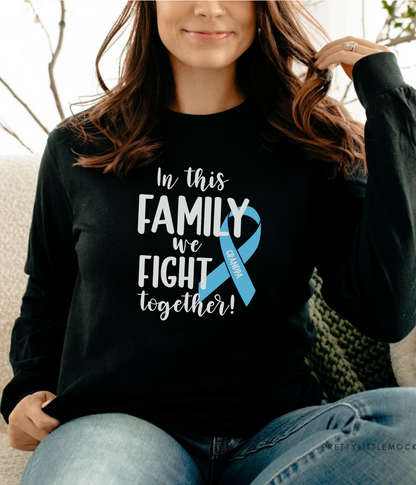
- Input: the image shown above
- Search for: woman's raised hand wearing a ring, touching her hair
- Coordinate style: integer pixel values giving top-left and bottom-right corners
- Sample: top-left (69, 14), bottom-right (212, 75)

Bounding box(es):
top-left (314, 35), bottom-right (390, 81)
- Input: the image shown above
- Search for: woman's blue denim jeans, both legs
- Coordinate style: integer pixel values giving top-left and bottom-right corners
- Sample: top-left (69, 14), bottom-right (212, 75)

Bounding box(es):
top-left (21, 387), bottom-right (416, 485)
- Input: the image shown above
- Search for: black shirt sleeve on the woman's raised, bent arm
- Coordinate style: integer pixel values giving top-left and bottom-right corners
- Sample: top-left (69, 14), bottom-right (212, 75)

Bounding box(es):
top-left (314, 52), bottom-right (416, 343)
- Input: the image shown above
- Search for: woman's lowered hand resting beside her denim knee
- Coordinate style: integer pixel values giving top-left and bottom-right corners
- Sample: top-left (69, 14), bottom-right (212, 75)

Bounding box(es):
top-left (7, 391), bottom-right (61, 451)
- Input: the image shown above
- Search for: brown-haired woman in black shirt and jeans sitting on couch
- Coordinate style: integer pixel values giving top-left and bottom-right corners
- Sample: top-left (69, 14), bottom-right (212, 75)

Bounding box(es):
top-left (2, 0), bottom-right (416, 485)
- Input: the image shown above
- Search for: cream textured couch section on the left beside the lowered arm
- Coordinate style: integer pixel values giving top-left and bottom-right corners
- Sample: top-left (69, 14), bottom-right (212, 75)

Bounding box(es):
top-left (0, 155), bottom-right (40, 485)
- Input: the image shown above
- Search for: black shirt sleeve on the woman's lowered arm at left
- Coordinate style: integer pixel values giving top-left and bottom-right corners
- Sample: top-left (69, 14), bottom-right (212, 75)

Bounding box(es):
top-left (1, 135), bottom-right (78, 423)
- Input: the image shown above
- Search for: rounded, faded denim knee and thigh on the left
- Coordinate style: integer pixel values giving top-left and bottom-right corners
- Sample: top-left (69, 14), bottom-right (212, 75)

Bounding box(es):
top-left (21, 413), bottom-right (205, 485)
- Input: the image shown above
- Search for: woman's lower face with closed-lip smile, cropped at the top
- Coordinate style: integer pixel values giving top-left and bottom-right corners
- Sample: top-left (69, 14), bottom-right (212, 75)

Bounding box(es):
top-left (156, 0), bottom-right (256, 73)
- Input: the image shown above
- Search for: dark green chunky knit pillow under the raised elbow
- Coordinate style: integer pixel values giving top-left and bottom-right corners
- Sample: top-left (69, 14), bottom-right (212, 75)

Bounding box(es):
top-left (305, 270), bottom-right (397, 402)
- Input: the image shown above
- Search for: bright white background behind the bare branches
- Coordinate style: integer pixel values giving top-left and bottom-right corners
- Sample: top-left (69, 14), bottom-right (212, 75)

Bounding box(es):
top-left (0, 0), bottom-right (416, 154)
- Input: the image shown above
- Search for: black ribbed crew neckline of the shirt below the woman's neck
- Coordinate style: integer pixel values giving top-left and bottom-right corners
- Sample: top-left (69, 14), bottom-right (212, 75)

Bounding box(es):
top-left (165, 96), bottom-right (250, 129)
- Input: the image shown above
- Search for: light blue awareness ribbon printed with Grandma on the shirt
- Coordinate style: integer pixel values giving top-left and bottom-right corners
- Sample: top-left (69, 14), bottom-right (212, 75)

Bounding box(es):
top-left (198, 207), bottom-right (261, 306)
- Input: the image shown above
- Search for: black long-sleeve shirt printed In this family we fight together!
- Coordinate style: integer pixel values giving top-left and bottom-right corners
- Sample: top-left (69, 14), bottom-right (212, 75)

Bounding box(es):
top-left (1, 52), bottom-right (416, 436)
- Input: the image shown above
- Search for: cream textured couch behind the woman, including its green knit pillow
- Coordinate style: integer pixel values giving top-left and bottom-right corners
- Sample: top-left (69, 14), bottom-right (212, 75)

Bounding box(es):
top-left (0, 155), bottom-right (416, 485)
